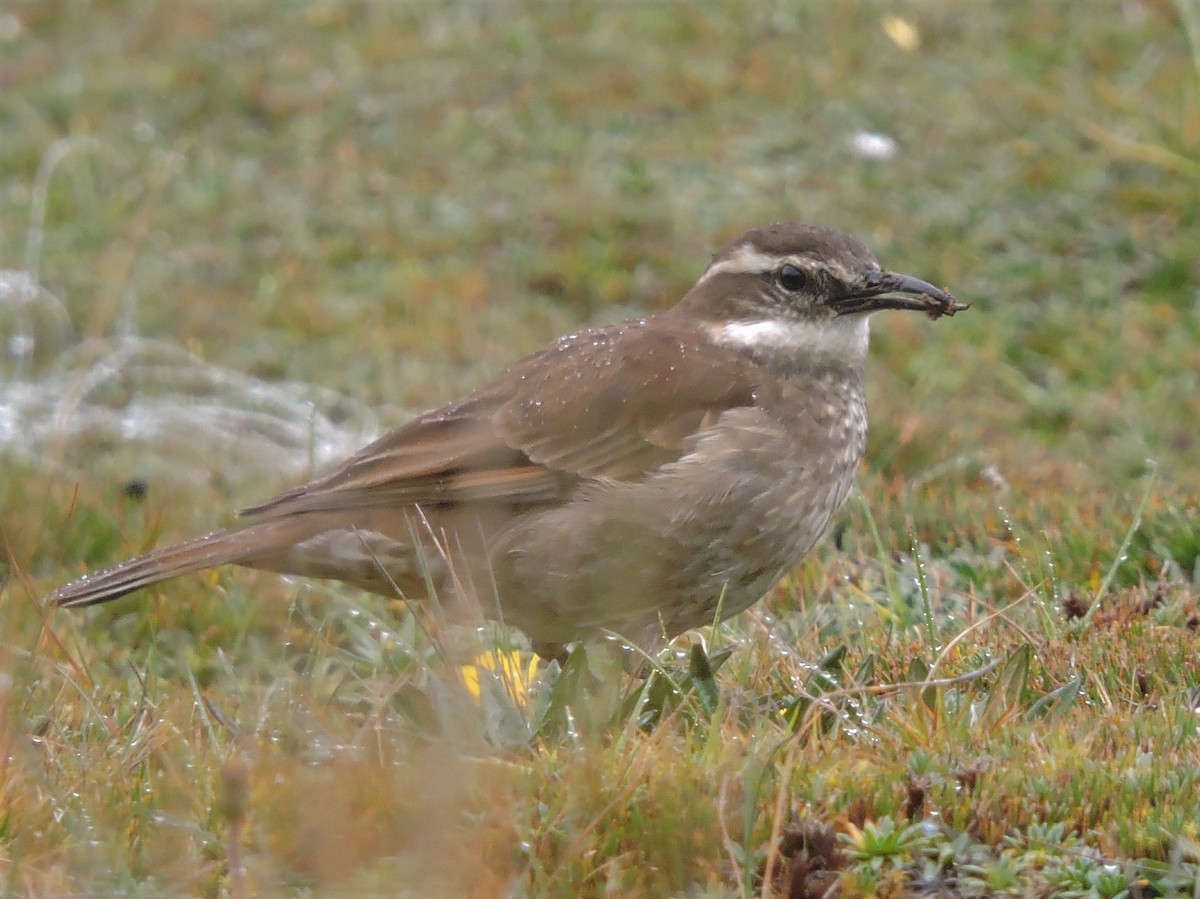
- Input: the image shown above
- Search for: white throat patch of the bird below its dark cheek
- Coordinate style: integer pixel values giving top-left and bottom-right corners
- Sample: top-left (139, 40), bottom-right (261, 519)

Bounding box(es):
top-left (708, 314), bottom-right (870, 361)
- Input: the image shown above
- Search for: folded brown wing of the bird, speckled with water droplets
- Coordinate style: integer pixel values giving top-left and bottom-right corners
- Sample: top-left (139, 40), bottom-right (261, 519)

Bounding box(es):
top-left (242, 319), bottom-right (756, 517)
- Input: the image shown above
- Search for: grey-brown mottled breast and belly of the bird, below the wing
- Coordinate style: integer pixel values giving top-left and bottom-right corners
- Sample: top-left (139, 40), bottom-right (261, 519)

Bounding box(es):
top-left (492, 369), bottom-right (866, 640)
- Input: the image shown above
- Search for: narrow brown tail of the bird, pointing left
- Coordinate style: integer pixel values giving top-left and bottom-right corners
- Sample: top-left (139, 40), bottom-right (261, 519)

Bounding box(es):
top-left (49, 519), bottom-right (308, 606)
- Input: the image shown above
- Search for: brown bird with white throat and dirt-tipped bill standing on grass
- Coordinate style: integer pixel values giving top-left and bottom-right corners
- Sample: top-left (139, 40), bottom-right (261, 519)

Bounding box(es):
top-left (49, 222), bottom-right (970, 658)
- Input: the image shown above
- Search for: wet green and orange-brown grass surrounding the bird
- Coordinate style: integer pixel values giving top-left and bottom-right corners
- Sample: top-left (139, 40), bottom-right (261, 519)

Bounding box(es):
top-left (0, 0), bottom-right (1200, 897)
